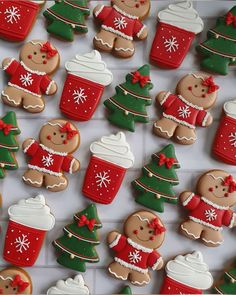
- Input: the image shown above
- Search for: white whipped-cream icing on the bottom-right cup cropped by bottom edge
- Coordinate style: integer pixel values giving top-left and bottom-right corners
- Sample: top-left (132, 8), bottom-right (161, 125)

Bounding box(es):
top-left (166, 251), bottom-right (213, 290)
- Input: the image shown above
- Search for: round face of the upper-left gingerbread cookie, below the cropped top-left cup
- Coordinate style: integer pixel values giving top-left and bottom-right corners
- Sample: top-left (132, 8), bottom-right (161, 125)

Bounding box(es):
top-left (20, 40), bottom-right (60, 74)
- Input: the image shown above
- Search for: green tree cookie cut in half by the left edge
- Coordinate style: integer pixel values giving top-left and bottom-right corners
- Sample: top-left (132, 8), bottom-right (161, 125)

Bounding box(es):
top-left (0, 112), bottom-right (20, 178)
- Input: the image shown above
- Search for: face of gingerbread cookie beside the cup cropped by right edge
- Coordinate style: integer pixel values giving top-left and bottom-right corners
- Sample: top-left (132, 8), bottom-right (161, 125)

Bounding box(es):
top-left (176, 72), bottom-right (219, 110)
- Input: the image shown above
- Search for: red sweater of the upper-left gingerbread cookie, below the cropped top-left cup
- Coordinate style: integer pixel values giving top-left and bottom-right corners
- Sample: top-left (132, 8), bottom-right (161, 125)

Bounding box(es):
top-left (3, 59), bottom-right (52, 97)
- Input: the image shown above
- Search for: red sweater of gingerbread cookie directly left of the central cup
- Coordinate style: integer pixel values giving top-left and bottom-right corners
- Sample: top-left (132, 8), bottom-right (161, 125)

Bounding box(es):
top-left (24, 140), bottom-right (74, 176)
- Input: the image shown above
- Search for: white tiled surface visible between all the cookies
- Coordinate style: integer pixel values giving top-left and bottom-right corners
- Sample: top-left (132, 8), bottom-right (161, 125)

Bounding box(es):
top-left (0, 0), bottom-right (236, 294)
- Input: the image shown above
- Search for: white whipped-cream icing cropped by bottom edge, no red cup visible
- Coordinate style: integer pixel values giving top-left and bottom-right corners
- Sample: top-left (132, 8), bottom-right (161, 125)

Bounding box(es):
top-left (47, 275), bottom-right (89, 295)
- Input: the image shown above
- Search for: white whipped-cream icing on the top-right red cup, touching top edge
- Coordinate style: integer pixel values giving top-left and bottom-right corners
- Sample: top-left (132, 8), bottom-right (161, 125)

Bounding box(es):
top-left (158, 1), bottom-right (204, 34)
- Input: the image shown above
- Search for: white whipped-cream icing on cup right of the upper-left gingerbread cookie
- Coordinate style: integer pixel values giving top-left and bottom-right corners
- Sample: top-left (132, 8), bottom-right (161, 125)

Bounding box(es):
top-left (65, 50), bottom-right (113, 86)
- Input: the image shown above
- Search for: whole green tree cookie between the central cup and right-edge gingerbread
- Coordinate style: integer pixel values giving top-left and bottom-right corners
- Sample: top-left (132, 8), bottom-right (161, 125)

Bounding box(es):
top-left (132, 144), bottom-right (180, 212)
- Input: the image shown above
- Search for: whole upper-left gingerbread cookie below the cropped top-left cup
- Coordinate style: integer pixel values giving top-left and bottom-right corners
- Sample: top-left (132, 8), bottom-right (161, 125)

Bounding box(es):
top-left (1, 40), bottom-right (60, 113)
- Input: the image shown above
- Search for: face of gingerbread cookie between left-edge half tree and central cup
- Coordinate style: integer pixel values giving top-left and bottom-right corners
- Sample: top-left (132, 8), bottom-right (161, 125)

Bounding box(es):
top-left (39, 120), bottom-right (80, 153)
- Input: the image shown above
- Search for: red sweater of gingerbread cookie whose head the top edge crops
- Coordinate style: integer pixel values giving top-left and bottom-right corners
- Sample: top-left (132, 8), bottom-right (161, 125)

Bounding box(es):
top-left (95, 5), bottom-right (145, 40)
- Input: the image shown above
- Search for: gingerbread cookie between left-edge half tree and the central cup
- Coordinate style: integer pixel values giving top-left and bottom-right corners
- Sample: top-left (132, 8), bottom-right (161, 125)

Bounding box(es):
top-left (23, 119), bottom-right (80, 192)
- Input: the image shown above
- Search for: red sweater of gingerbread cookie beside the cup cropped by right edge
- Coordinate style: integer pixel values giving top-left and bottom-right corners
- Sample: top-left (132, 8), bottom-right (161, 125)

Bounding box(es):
top-left (161, 92), bottom-right (209, 129)
